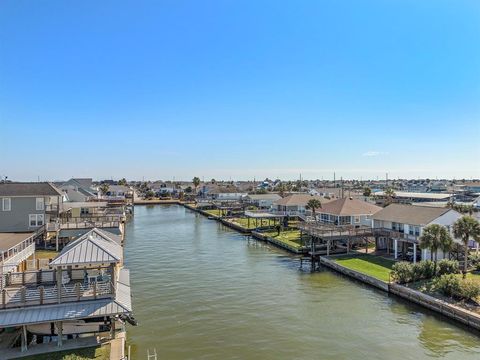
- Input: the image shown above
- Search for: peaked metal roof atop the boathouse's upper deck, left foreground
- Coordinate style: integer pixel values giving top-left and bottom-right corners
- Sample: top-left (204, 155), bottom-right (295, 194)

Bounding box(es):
top-left (50, 228), bottom-right (123, 266)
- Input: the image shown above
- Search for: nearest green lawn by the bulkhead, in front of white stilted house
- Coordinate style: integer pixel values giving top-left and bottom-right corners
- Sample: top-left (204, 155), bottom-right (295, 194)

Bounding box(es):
top-left (333, 254), bottom-right (395, 282)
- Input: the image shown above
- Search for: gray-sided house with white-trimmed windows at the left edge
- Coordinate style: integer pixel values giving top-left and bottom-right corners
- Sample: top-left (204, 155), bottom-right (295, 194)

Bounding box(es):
top-left (0, 182), bottom-right (63, 232)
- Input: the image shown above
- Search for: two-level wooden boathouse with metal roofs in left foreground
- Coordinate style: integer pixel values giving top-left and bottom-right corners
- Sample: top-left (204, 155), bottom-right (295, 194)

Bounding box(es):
top-left (0, 229), bottom-right (132, 358)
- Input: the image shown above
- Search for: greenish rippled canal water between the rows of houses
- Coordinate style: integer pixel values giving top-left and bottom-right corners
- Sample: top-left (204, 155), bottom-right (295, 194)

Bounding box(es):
top-left (125, 205), bottom-right (480, 360)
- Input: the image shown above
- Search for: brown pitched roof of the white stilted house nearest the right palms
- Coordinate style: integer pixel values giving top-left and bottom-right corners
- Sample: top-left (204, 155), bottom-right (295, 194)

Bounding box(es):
top-left (372, 204), bottom-right (453, 225)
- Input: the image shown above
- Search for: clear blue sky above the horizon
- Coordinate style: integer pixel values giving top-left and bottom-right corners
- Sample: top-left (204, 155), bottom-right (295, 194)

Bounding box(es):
top-left (0, 0), bottom-right (480, 180)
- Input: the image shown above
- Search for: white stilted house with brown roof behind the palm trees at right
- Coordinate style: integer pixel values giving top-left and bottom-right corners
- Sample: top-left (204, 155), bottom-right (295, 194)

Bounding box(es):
top-left (372, 204), bottom-right (462, 260)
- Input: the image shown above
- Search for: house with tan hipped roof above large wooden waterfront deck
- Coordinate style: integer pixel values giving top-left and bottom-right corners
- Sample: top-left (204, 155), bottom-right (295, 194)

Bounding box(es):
top-left (316, 197), bottom-right (382, 226)
